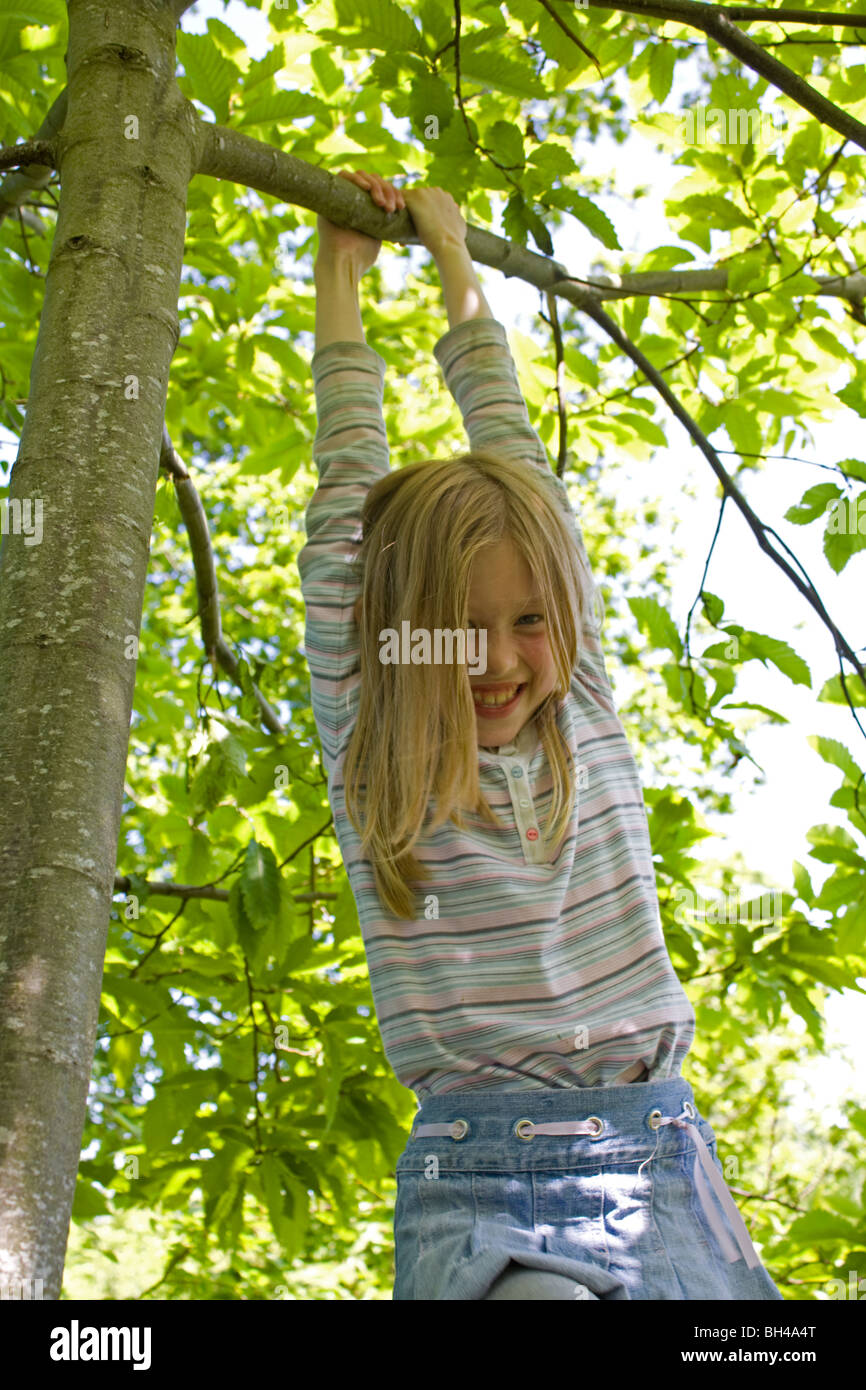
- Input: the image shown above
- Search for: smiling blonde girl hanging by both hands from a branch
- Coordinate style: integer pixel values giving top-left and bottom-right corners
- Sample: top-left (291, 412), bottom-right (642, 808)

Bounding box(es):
top-left (299, 171), bottom-right (781, 1300)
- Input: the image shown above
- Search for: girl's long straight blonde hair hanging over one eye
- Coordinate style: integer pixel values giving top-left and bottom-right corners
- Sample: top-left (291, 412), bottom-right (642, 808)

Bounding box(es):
top-left (345, 449), bottom-right (594, 919)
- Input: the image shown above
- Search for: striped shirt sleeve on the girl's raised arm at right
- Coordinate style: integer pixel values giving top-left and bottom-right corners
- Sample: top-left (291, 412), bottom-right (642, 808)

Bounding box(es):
top-left (434, 318), bottom-right (614, 712)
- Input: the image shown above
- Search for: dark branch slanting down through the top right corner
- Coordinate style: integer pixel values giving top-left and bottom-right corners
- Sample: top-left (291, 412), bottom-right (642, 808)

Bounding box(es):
top-left (578, 0), bottom-right (866, 150)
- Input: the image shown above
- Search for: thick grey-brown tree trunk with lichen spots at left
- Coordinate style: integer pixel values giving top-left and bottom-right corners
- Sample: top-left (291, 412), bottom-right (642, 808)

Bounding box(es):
top-left (0, 0), bottom-right (196, 1298)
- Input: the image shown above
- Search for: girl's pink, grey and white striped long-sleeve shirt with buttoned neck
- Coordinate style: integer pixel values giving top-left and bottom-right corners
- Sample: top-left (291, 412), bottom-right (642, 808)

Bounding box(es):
top-left (299, 318), bottom-right (695, 1101)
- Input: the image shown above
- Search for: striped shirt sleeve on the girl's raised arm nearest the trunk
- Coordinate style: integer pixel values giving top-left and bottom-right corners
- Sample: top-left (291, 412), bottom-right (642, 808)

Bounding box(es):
top-left (297, 333), bottom-right (389, 777)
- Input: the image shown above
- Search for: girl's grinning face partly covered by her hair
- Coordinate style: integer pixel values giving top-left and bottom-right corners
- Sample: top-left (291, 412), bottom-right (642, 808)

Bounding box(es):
top-left (468, 539), bottom-right (556, 748)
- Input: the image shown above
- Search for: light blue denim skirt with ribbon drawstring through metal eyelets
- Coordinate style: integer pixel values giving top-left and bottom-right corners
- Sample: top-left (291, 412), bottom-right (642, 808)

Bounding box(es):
top-left (393, 1077), bottom-right (781, 1301)
